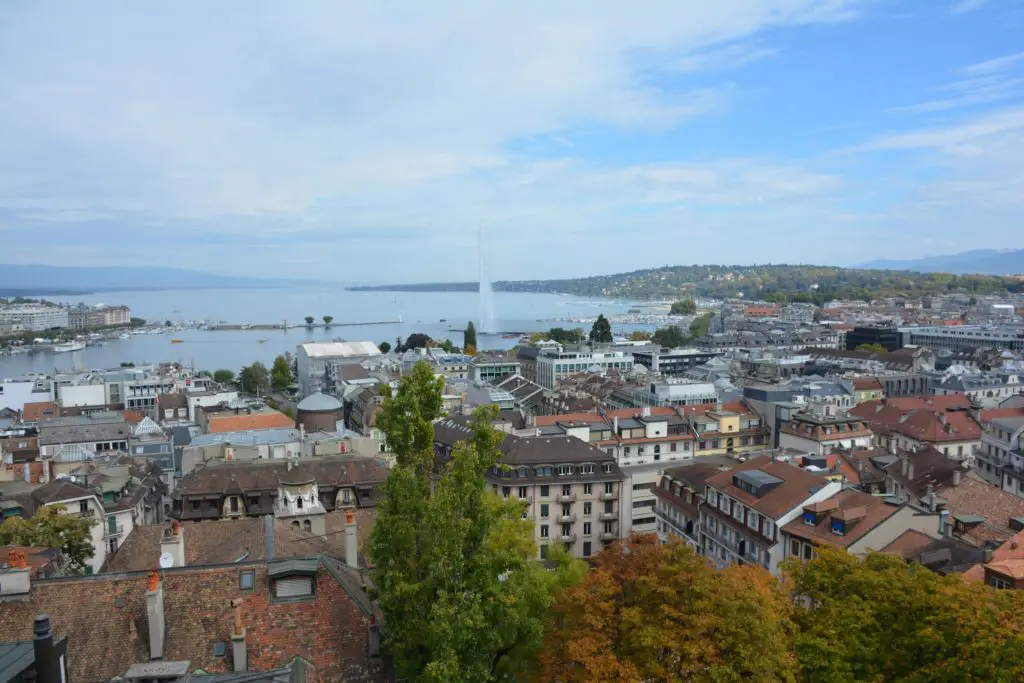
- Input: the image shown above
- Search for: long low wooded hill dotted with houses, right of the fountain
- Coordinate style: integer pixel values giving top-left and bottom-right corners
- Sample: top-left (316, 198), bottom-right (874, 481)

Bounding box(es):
top-left (495, 265), bottom-right (1024, 305)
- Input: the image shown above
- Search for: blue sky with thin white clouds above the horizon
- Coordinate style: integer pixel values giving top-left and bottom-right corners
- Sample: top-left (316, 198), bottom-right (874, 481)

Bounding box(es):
top-left (0, 0), bottom-right (1024, 283)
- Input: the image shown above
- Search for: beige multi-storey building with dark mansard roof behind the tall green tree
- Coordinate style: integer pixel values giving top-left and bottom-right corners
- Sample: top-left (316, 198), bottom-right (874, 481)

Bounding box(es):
top-left (434, 419), bottom-right (630, 559)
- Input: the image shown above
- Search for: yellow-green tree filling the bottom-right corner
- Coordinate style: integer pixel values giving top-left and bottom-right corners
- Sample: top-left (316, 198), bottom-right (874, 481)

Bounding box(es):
top-left (787, 549), bottom-right (1024, 683)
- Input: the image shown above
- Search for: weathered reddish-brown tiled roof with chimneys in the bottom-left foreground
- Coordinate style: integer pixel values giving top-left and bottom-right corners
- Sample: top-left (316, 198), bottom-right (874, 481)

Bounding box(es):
top-left (0, 558), bottom-right (386, 683)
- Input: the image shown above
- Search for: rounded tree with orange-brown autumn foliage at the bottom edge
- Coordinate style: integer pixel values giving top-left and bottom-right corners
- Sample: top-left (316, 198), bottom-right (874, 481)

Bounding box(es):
top-left (538, 535), bottom-right (797, 683)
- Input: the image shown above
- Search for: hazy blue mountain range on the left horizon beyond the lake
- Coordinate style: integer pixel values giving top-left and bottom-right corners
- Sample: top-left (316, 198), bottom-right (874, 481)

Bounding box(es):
top-left (0, 264), bottom-right (326, 296)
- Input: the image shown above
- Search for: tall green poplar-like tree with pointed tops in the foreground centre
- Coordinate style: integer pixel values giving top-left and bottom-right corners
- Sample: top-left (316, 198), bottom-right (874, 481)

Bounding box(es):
top-left (370, 362), bottom-right (581, 683)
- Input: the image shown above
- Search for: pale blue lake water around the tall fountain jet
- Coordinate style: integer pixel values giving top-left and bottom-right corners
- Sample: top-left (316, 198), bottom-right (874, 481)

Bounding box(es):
top-left (0, 289), bottom-right (636, 378)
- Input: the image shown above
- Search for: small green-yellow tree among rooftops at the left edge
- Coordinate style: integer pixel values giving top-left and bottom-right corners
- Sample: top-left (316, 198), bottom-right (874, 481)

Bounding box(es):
top-left (0, 505), bottom-right (95, 573)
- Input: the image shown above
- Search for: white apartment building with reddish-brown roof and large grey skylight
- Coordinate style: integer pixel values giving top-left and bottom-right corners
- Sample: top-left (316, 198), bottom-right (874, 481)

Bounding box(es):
top-left (700, 456), bottom-right (843, 573)
